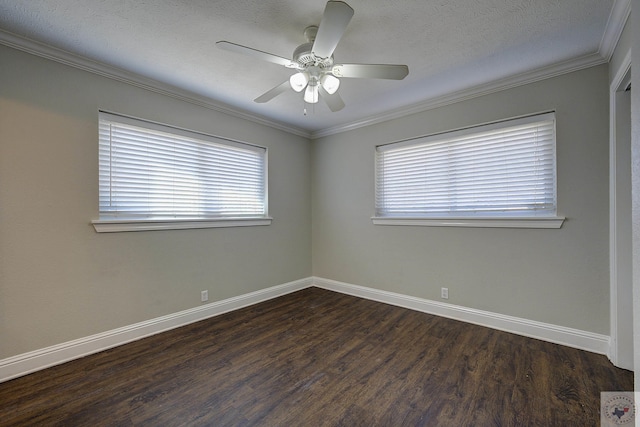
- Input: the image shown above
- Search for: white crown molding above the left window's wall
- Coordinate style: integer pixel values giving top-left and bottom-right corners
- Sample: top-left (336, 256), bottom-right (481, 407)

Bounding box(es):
top-left (0, 29), bottom-right (311, 138)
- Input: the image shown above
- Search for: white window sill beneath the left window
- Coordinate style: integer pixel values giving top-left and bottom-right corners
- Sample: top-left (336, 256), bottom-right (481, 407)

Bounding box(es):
top-left (91, 217), bottom-right (273, 233)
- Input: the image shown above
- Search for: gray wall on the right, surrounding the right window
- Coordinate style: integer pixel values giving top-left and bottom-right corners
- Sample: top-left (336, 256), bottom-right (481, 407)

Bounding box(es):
top-left (312, 65), bottom-right (609, 334)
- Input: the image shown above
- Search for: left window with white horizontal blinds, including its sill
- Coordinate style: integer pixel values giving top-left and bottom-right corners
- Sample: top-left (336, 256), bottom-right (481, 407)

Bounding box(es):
top-left (94, 112), bottom-right (269, 231)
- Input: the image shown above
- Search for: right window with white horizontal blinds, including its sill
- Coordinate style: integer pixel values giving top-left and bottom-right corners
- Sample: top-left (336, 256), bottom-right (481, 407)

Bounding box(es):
top-left (374, 113), bottom-right (562, 228)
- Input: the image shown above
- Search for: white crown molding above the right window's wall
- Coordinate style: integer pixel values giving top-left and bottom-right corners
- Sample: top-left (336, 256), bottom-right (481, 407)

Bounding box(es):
top-left (311, 53), bottom-right (608, 139)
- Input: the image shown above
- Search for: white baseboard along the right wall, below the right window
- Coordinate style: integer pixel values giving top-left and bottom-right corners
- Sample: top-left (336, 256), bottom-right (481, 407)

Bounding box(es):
top-left (313, 277), bottom-right (609, 355)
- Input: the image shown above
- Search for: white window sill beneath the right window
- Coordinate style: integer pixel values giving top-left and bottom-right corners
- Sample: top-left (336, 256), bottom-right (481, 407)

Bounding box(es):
top-left (371, 216), bottom-right (565, 228)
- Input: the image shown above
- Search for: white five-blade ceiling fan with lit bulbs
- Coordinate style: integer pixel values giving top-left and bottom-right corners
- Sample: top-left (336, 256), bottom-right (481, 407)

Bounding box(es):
top-left (216, 0), bottom-right (409, 111)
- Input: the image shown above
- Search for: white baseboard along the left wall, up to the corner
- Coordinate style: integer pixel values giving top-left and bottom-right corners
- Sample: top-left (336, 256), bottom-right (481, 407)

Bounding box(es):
top-left (0, 278), bottom-right (313, 382)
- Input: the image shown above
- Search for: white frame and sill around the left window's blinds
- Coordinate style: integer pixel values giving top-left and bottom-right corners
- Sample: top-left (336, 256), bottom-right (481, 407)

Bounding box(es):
top-left (91, 111), bottom-right (272, 233)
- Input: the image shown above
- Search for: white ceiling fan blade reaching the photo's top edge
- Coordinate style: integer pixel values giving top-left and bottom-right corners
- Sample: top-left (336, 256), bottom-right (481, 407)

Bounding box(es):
top-left (311, 1), bottom-right (353, 58)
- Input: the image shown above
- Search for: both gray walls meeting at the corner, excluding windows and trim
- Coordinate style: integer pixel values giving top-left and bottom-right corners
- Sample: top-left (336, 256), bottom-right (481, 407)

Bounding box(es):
top-left (0, 41), bottom-right (609, 359)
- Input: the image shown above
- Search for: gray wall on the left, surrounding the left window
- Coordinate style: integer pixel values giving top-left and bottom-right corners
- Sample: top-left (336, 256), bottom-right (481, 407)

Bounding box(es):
top-left (0, 46), bottom-right (311, 359)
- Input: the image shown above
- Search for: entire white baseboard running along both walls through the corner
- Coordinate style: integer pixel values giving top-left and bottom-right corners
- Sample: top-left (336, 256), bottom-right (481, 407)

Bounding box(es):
top-left (0, 277), bottom-right (609, 383)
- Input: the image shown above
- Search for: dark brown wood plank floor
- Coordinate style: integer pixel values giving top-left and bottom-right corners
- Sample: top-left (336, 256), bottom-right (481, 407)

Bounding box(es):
top-left (0, 288), bottom-right (633, 427)
